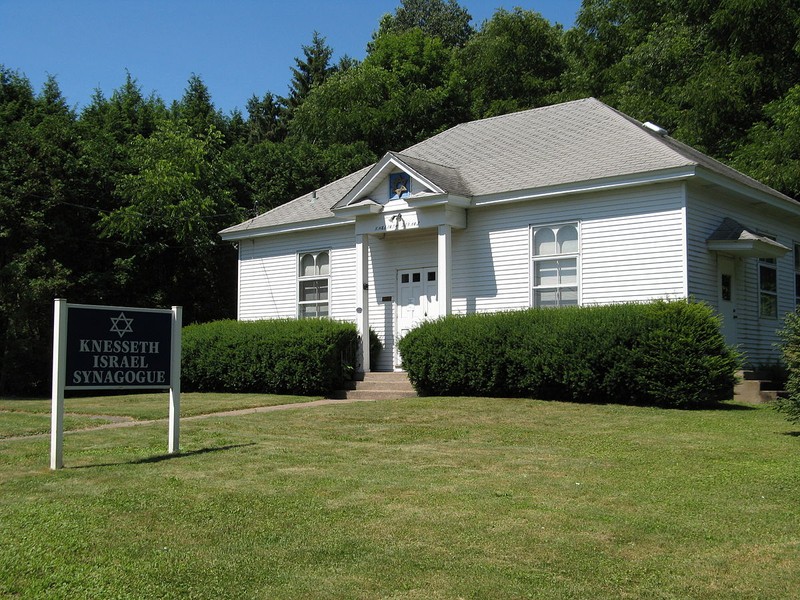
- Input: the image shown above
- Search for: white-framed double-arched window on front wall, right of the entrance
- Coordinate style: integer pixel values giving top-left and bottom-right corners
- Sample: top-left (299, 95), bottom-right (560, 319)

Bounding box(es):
top-left (531, 223), bottom-right (580, 307)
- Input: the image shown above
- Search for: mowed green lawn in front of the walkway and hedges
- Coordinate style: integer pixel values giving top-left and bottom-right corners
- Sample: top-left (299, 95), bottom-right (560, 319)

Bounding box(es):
top-left (0, 398), bottom-right (800, 599)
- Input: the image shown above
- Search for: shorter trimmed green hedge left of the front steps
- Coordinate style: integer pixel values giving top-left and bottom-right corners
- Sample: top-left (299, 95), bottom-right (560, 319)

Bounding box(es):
top-left (181, 319), bottom-right (357, 395)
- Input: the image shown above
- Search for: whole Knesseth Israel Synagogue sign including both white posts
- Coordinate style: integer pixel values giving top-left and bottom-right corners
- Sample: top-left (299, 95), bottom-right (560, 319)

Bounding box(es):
top-left (50, 299), bottom-right (182, 469)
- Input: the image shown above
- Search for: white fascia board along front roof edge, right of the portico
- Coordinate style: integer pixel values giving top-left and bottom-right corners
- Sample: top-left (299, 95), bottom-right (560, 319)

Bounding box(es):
top-left (472, 165), bottom-right (696, 206)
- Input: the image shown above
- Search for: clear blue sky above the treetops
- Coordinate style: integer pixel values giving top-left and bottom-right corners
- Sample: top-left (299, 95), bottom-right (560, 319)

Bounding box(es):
top-left (0, 0), bottom-right (580, 114)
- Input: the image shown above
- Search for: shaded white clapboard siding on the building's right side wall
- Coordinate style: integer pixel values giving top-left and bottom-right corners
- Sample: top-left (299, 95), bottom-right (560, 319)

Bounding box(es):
top-left (687, 186), bottom-right (800, 366)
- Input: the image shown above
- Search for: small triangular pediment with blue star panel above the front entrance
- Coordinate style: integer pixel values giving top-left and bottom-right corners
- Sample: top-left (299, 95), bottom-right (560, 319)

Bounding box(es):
top-left (333, 152), bottom-right (467, 211)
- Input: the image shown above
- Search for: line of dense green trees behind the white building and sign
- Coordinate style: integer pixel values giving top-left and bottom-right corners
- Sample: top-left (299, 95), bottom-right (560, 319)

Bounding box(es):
top-left (0, 0), bottom-right (800, 394)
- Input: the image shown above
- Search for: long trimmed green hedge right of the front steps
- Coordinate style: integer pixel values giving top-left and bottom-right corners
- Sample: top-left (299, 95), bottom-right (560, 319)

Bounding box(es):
top-left (400, 301), bottom-right (740, 407)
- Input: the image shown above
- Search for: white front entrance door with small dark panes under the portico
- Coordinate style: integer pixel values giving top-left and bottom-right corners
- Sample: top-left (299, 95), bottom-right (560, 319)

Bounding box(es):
top-left (394, 267), bottom-right (439, 368)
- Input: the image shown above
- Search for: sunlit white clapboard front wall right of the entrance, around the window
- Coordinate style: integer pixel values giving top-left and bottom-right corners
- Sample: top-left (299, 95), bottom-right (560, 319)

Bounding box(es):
top-left (453, 184), bottom-right (686, 313)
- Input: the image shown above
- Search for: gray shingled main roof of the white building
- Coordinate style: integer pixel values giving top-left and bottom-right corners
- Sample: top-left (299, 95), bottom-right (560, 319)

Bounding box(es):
top-left (224, 98), bottom-right (795, 233)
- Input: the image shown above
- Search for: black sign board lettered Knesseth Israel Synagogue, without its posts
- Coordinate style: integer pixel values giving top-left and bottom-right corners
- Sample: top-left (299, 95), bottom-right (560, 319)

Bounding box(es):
top-left (64, 306), bottom-right (172, 390)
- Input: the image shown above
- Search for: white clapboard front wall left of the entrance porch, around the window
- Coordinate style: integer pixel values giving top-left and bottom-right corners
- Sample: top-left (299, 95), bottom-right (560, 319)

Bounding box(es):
top-left (239, 225), bottom-right (356, 321)
